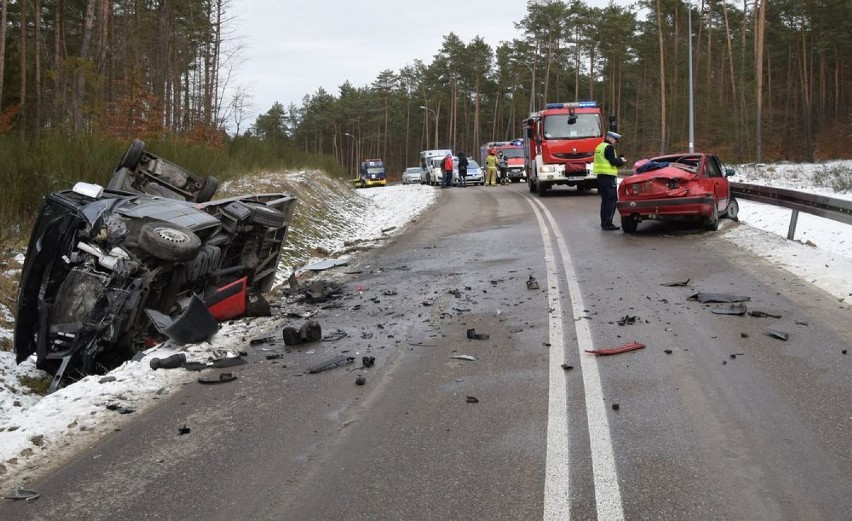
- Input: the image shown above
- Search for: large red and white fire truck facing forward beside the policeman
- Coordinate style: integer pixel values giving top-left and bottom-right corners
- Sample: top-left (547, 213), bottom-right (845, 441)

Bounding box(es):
top-left (524, 101), bottom-right (617, 196)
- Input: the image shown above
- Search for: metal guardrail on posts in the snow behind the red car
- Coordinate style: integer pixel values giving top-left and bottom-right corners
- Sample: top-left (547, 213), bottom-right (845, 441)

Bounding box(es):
top-left (731, 183), bottom-right (852, 241)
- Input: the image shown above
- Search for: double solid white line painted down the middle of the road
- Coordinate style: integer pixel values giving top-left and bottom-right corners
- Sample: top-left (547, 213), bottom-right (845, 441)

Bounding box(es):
top-left (522, 194), bottom-right (624, 521)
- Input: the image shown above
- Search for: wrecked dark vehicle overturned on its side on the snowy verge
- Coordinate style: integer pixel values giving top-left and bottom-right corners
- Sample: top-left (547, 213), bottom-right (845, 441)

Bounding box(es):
top-left (14, 140), bottom-right (295, 384)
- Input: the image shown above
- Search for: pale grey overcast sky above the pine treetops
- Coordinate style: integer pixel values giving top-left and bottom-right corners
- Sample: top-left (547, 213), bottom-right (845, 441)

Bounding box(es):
top-left (231, 0), bottom-right (626, 127)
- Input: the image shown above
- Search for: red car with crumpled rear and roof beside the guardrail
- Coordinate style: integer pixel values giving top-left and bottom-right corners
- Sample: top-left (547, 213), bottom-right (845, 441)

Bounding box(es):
top-left (617, 152), bottom-right (739, 233)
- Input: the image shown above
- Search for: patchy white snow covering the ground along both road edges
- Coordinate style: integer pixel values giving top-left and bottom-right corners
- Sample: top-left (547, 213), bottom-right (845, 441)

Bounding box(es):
top-left (0, 161), bottom-right (852, 495)
